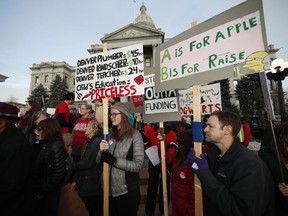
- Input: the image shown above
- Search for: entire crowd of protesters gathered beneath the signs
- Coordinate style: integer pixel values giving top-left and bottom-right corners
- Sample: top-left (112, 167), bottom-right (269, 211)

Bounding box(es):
top-left (0, 92), bottom-right (288, 216)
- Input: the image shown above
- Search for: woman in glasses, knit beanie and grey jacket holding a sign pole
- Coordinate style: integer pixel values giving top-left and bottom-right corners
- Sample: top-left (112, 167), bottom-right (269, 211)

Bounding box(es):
top-left (97, 102), bottom-right (144, 216)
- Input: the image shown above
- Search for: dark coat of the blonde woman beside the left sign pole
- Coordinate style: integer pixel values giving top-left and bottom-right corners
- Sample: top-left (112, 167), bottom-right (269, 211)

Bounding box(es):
top-left (74, 137), bottom-right (102, 197)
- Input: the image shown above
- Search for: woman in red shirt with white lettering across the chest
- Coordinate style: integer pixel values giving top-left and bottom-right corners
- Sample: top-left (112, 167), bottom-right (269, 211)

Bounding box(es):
top-left (68, 104), bottom-right (95, 162)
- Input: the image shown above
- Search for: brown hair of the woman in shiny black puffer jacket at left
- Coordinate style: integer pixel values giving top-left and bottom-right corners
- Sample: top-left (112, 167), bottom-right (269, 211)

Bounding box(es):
top-left (38, 118), bottom-right (64, 145)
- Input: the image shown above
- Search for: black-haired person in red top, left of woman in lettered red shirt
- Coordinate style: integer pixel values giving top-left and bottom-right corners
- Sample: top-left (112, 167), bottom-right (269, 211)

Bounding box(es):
top-left (54, 92), bottom-right (75, 148)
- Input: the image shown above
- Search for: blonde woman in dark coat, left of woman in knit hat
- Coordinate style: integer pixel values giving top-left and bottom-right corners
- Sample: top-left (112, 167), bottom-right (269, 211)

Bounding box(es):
top-left (72, 120), bottom-right (103, 216)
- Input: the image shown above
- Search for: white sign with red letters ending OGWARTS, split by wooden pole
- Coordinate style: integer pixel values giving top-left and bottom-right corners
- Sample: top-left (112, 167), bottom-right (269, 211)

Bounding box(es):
top-left (179, 83), bottom-right (222, 115)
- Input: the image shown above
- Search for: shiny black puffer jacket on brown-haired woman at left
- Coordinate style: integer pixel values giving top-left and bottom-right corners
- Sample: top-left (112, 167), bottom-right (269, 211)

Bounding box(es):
top-left (35, 141), bottom-right (67, 196)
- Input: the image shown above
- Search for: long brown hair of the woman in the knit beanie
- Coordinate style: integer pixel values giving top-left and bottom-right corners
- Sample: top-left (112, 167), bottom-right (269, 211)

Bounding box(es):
top-left (110, 112), bottom-right (134, 141)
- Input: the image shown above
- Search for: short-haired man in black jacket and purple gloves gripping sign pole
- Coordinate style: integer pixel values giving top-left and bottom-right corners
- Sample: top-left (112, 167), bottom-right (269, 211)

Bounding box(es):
top-left (188, 111), bottom-right (275, 216)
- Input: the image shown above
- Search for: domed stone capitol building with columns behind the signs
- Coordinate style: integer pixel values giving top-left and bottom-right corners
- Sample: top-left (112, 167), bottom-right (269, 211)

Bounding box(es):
top-left (29, 3), bottom-right (165, 100)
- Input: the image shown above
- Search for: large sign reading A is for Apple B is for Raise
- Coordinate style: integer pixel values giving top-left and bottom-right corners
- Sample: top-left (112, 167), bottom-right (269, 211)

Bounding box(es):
top-left (155, 0), bottom-right (268, 92)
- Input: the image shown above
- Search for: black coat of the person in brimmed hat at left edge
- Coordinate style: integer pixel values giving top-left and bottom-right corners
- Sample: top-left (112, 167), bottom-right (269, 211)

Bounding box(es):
top-left (0, 126), bottom-right (33, 216)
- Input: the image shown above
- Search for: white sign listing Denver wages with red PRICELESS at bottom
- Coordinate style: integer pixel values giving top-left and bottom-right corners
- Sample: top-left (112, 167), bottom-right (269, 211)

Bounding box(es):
top-left (75, 44), bottom-right (144, 101)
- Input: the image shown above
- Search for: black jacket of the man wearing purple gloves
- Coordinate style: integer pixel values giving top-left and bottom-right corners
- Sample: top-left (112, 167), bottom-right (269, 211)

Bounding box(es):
top-left (197, 138), bottom-right (275, 216)
